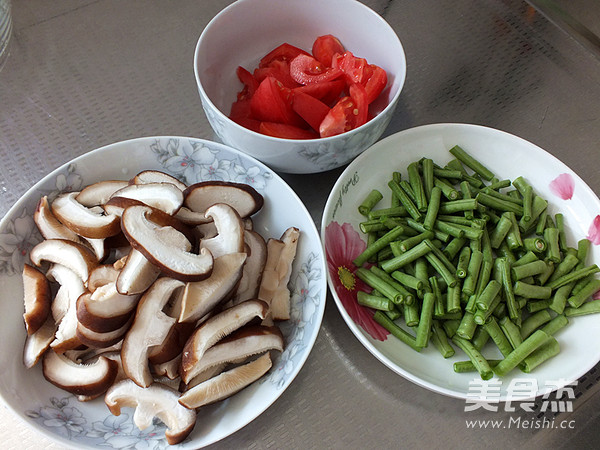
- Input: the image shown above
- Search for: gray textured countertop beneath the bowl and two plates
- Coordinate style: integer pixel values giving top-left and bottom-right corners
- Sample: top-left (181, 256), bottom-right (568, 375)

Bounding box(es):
top-left (0, 0), bottom-right (600, 449)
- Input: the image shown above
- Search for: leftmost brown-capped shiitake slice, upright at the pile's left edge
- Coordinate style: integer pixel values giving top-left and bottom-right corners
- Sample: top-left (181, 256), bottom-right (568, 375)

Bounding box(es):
top-left (23, 264), bottom-right (52, 335)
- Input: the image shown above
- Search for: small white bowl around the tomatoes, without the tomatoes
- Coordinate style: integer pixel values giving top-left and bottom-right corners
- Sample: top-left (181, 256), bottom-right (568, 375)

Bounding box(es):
top-left (194, 0), bottom-right (406, 173)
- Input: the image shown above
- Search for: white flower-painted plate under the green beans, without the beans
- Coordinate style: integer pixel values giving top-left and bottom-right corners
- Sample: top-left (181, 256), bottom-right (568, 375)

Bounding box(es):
top-left (321, 124), bottom-right (600, 400)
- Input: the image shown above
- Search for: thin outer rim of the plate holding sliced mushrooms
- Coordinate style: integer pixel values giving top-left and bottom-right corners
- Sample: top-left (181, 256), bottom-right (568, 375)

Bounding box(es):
top-left (0, 134), bottom-right (328, 449)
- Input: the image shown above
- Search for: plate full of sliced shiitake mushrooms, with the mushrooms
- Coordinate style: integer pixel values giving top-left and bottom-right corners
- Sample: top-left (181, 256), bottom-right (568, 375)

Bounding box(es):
top-left (0, 137), bottom-right (327, 449)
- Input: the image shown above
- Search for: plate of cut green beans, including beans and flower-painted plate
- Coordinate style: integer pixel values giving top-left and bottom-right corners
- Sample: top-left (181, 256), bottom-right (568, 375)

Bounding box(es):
top-left (321, 124), bottom-right (600, 401)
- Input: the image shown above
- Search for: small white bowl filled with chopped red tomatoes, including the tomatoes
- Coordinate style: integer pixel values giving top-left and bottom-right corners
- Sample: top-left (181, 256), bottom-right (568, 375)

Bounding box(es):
top-left (194, 0), bottom-right (406, 173)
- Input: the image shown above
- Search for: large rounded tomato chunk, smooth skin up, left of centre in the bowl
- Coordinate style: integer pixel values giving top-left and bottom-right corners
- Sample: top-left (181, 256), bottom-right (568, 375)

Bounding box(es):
top-left (250, 77), bottom-right (304, 126)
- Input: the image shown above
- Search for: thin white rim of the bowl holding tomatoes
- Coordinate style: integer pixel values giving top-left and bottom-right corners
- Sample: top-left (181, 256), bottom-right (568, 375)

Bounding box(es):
top-left (194, 0), bottom-right (407, 144)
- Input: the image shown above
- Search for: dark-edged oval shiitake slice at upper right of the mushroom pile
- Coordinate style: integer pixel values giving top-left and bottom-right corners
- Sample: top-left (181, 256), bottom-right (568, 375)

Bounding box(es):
top-left (183, 181), bottom-right (264, 218)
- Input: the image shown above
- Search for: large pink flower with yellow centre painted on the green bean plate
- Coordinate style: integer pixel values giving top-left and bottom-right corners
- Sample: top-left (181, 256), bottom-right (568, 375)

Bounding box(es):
top-left (325, 222), bottom-right (389, 341)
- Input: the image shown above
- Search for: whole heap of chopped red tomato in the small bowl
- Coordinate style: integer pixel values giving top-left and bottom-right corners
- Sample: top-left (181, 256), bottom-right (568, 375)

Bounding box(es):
top-left (229, 34), bottom-right (387, 139)
